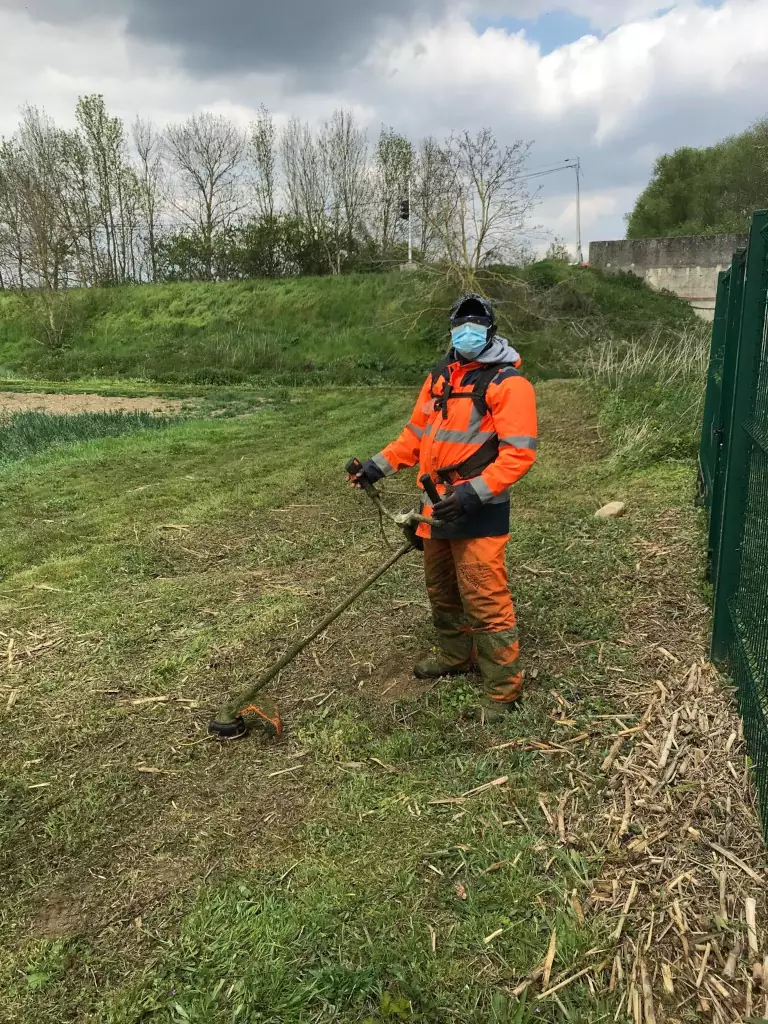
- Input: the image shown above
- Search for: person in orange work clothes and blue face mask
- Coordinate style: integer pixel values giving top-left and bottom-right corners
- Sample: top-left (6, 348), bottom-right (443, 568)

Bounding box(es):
top-left (349, 294), bottom-right (538, 723)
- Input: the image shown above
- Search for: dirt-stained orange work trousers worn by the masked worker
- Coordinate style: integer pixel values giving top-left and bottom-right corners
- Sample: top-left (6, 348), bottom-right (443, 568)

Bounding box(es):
top-left (424, 536), bottom-right (522, 703)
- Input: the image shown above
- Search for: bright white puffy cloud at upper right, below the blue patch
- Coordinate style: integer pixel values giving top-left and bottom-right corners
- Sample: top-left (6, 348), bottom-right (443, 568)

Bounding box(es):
top-left (371, 0), bottom-right (768, 137)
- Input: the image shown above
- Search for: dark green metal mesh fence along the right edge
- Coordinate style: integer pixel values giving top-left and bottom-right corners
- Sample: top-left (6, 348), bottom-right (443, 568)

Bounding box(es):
top-left (699, 211), bottom-right (768, 829)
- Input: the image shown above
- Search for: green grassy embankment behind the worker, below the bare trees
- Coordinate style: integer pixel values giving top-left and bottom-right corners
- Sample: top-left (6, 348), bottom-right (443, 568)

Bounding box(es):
top-left (0, 262), bottom-right (693, 386)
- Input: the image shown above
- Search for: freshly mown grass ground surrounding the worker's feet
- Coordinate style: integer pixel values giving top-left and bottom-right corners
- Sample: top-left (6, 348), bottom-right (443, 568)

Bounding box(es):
top-left (0, 383), bottom-right (697, 1024)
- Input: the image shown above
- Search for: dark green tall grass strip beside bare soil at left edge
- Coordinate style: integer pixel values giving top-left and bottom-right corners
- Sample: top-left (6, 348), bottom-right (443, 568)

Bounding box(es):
top-left (0, 413), bottom-right (172, 466)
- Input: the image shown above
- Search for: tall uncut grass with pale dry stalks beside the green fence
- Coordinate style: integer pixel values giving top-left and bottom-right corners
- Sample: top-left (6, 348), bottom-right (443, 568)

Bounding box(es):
top-left (585, 324), bottom-right (710, 466)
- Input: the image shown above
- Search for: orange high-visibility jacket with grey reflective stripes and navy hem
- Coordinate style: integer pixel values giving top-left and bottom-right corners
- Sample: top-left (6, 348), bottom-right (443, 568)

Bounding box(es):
top-left (373, 337), bottom-right (538, 540)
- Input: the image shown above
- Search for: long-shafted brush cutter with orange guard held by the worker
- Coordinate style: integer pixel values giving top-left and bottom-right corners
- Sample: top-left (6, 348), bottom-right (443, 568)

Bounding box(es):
top-left (208, 459), bottom-right (439, 739)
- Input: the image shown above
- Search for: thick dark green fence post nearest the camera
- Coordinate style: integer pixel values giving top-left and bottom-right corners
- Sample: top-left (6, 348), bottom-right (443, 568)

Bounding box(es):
top-left (711, 210), bottom-right (768, 667)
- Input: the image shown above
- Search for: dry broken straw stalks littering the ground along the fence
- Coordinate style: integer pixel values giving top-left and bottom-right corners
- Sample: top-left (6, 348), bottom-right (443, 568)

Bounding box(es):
top-left (507, 511), bottom-right (768, 1024)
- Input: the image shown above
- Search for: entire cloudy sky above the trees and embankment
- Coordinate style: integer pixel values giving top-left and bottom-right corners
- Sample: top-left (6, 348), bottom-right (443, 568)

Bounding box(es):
top-left (0, 0), bottom-right (768, 256)
